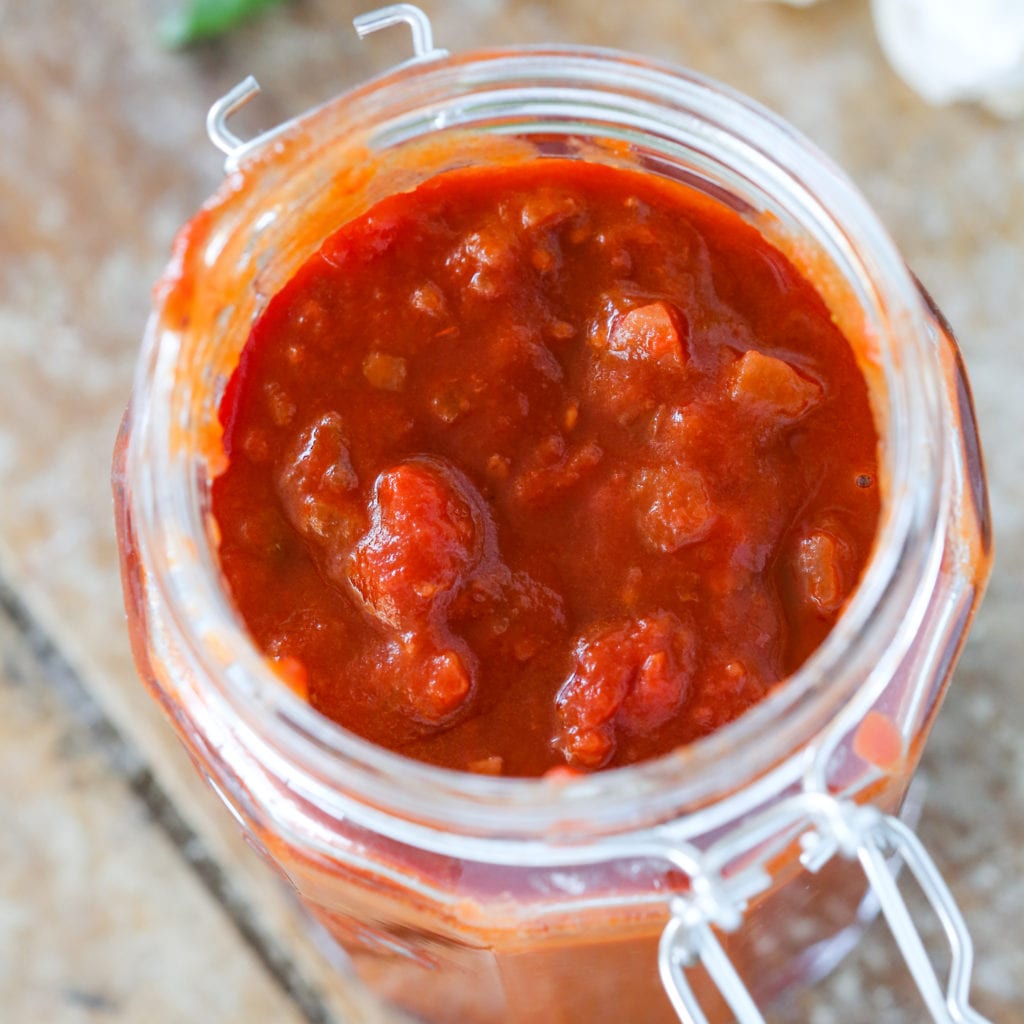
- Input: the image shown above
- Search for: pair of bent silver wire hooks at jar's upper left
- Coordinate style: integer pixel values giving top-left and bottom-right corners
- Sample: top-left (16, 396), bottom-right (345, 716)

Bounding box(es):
top-left (206, 3), bottom-right (447, 173)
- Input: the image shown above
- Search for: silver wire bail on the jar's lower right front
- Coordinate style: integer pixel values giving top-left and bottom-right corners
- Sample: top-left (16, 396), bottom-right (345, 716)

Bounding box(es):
top-left (658, 792), bottom-right (990, 1024)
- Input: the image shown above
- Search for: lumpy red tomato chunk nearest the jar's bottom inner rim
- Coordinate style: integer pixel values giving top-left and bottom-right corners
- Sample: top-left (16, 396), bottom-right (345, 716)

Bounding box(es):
top-left (556, 611), bottom-right (693, 770)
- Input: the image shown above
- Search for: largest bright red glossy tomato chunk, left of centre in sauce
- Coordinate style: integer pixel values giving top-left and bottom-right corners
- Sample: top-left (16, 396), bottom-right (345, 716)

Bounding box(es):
top-left (346, 459), bottom-right (483, 630)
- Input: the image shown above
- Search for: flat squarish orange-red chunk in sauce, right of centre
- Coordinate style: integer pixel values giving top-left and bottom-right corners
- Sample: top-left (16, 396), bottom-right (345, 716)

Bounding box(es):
top-left (634, 466), bottom-right (715, 554)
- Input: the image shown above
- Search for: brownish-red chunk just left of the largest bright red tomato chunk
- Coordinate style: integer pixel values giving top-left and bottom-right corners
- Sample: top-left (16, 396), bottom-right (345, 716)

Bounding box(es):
top-left (276, 413), bottom-right (359, 543)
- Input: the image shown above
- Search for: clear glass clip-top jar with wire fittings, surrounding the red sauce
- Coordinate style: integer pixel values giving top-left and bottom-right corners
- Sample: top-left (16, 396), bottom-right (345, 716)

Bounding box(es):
top-left (114, 5), bottom-right (990, 1024)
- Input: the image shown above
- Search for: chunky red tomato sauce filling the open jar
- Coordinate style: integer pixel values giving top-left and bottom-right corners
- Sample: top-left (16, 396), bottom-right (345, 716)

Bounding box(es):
top-left (213, 160), bottom-right (879, 775)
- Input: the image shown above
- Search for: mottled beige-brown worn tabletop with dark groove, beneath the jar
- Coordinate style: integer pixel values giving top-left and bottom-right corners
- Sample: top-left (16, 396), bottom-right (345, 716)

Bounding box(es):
top-left (0, 0), bottom-right (1024, 1024)
